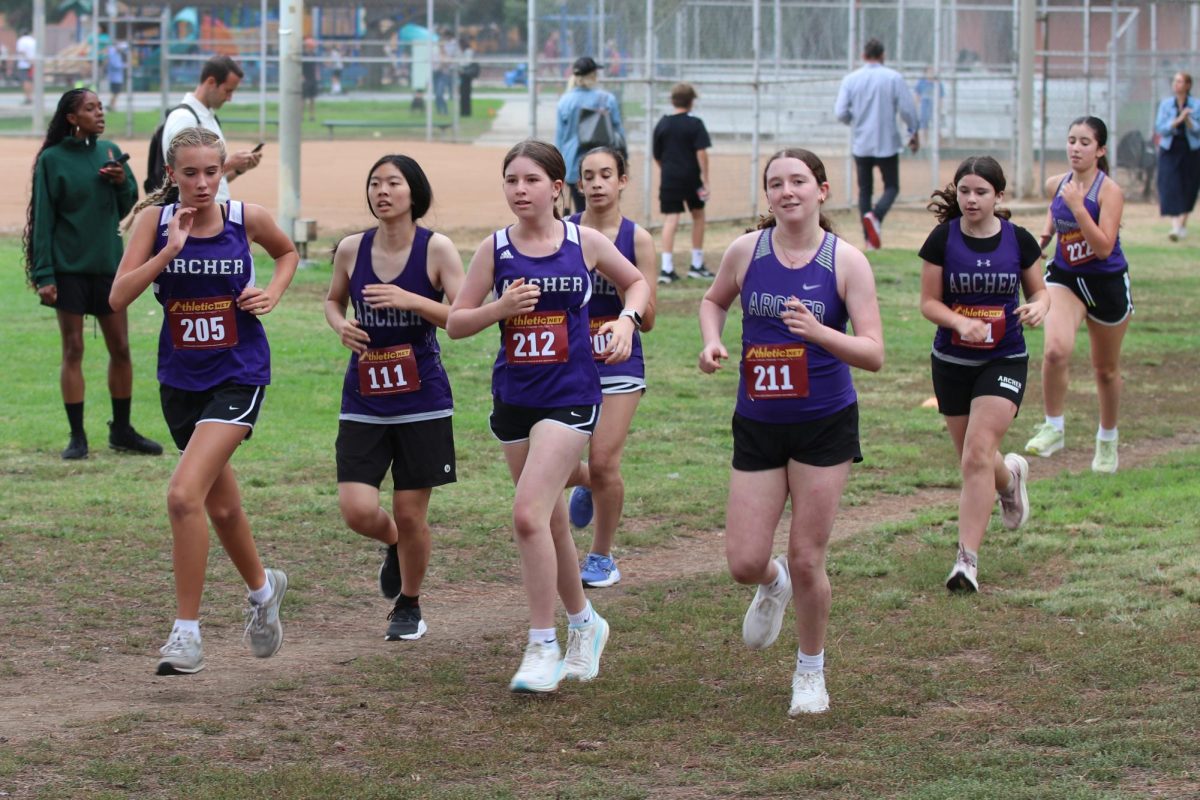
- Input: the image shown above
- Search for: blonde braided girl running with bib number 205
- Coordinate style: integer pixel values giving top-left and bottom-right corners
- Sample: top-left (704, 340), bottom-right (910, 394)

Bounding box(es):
top-left (109, 127), bottom-right (299, 675)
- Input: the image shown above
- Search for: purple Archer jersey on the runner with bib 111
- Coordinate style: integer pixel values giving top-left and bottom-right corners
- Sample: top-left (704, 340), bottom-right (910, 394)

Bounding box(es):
top-left (338, 227), bottom-right (454, 425)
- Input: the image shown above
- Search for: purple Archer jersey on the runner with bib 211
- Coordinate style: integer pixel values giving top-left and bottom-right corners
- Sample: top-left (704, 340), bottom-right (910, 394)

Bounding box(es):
top-left (737, 228), bottom-right (858, 423)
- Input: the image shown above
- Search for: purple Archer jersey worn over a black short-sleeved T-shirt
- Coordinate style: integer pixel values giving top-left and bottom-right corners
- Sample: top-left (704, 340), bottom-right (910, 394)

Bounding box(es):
top-left (934, 218), bottom-right (1032, 365)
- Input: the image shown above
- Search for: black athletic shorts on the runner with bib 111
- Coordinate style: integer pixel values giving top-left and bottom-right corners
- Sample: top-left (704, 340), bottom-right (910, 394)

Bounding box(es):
top-left (337, 416), bottom-right (458, 492)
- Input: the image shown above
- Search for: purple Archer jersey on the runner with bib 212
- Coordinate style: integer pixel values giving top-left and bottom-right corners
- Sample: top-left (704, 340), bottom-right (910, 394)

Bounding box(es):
top-left (492, 219), bottom-right (601, 408)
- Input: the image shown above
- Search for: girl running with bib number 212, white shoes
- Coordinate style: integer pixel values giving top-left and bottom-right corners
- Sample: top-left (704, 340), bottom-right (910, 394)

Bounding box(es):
top-left (446, 139), bottom-right (650, 692)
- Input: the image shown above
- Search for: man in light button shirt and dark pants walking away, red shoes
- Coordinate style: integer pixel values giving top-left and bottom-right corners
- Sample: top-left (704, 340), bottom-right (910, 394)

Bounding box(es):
top-left (834, 38), bottom-right (920, 249)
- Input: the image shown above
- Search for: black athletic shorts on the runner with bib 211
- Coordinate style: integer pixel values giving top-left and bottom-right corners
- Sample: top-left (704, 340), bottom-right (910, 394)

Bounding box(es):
top-left (733, 403), bottom-right (863, 473)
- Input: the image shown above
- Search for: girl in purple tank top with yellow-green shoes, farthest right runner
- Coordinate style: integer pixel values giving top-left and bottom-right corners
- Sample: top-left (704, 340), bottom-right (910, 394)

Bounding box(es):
top-left (1025, 116), bottom-right (1133, 473)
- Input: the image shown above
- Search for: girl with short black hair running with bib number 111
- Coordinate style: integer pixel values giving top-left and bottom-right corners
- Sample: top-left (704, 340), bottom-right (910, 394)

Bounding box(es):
top-left (325, 155), bottom-right (463, 642)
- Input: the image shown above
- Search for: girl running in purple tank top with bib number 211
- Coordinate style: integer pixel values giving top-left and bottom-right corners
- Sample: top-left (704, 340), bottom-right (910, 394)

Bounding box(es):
top-left (700, 149), bottom-right (883, 716)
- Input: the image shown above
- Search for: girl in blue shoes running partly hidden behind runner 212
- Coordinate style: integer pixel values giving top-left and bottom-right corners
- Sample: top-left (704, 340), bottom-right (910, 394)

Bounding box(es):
top-left (569, 148), bottom-right (658, 588)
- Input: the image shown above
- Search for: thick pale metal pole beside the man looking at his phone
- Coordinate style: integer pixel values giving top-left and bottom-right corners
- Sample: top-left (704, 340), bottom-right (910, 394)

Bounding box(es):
top-left (278, 0), bottom-right (304, 239)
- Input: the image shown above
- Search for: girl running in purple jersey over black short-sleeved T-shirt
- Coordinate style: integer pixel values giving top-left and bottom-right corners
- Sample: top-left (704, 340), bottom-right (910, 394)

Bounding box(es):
top-left (920, 156), bottom-right (1050, 591)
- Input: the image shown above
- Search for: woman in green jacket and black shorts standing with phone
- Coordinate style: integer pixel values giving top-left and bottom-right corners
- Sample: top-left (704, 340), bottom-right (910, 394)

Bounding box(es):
top-left (24, 89), bottom-right (162, 458)
